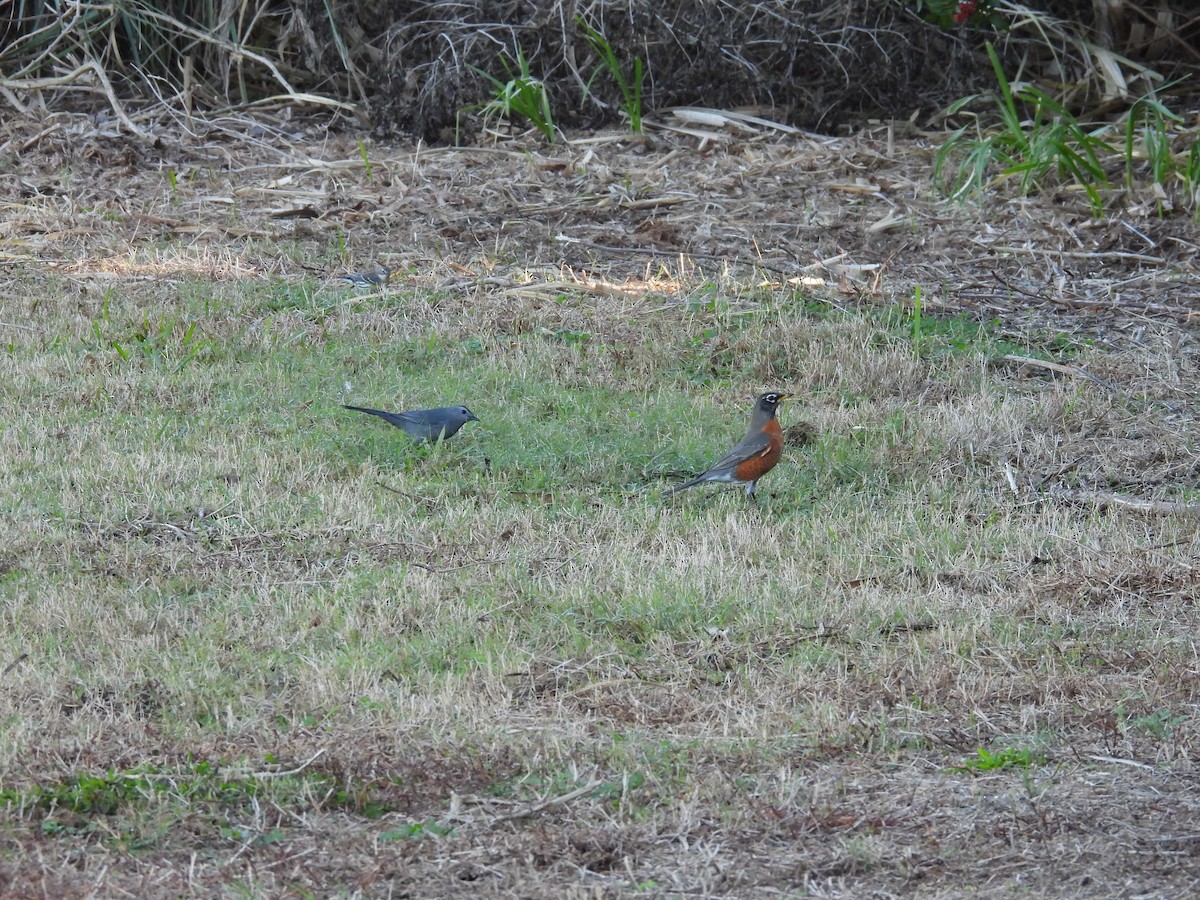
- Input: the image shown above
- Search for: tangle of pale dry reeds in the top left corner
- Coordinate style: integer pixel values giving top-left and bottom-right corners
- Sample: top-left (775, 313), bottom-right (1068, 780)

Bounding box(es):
top-left (0, 0), bottom-right (367, 133)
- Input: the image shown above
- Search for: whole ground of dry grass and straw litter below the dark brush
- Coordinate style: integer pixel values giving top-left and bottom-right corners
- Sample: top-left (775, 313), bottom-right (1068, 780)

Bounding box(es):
top-left (0, 109), bottom-right (1200, 898)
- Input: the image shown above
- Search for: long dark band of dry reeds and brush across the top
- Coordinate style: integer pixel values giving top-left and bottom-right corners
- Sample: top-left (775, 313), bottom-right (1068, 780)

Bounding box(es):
top-left (0, 0), bottom-right (1200, 140)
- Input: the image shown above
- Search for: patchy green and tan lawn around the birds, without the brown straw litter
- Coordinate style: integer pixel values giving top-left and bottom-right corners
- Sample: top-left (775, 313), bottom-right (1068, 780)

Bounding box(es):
top-left (0, 262), bottom-right (1196, 893)
